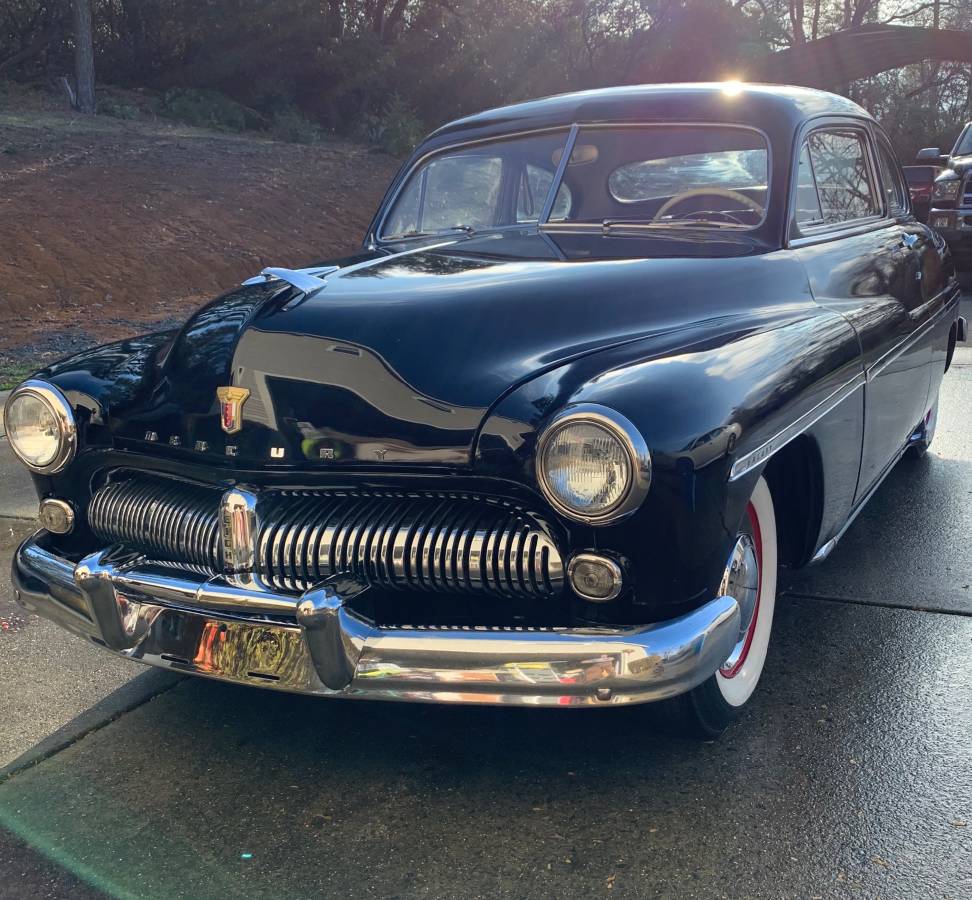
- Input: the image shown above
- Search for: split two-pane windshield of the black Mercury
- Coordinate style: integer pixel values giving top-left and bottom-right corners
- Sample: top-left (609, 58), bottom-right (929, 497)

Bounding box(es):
top-left (380, 125), bottom-right (769, 240)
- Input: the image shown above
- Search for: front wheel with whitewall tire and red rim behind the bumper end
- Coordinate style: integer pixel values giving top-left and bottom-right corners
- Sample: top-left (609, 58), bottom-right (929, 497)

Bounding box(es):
top-left (669, 478), bottom-right (777, 740)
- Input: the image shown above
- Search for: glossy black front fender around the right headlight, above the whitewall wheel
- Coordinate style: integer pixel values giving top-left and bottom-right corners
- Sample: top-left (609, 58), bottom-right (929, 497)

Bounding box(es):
top-left (476, 301), bottom-right (860, 618)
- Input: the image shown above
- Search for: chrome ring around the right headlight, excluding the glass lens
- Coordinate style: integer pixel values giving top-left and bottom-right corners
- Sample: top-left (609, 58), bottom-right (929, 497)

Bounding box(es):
top-left (534, 403), bottom-right (651, 525)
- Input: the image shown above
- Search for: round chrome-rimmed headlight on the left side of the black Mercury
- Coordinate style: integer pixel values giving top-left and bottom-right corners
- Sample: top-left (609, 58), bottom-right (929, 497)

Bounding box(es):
top-left (3, 381), bottom-right (77, 474)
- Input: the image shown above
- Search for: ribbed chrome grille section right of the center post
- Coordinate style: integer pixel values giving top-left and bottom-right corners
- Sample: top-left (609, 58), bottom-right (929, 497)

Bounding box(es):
top-left (259, 491), bottom-right (564, 597)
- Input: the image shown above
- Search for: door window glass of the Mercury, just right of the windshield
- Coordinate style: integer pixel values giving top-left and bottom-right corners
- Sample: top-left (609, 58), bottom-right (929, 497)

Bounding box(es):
top-left (807, 130), bottom-right (881, 225)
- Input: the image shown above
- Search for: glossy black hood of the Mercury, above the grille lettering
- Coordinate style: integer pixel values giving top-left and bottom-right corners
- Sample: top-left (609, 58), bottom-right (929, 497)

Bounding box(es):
top-left (108, 234), bottom-right (768, 466)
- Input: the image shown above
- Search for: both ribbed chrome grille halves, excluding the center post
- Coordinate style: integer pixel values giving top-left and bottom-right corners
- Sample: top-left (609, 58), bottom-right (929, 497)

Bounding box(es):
top-left (88, 476), bottom-right (564, 598)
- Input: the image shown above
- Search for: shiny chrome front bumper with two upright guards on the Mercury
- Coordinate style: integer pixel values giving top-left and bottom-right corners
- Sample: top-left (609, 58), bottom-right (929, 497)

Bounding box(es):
top-left (13, 531), bottom-right (739, 706)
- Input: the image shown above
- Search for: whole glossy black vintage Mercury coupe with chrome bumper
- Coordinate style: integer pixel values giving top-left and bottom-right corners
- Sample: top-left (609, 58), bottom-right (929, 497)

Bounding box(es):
top-left (5, 84), bottom-right (964, 735)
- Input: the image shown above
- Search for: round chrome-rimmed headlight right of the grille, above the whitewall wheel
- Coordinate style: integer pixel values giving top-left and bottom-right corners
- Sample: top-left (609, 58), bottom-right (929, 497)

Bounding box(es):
top-left (537, 404), bottom-right (651, 524)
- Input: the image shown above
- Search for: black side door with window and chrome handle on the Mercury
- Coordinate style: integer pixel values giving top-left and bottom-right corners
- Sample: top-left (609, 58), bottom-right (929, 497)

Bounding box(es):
top-left (790, 119), bottom-right (931, 503)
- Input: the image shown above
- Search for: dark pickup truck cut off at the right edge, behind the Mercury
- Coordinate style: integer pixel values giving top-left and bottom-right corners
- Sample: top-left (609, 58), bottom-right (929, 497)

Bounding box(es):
top-left (918, 122), bottom-right (972, 273)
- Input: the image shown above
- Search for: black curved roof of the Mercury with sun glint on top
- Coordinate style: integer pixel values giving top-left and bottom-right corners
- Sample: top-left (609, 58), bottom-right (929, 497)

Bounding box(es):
top-left (430, 81), bottom-right (871, 138)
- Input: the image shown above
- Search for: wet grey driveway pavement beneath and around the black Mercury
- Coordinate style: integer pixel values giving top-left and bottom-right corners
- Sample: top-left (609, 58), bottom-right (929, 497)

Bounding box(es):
top-left (0, 302), bottom-right (972, 900)
